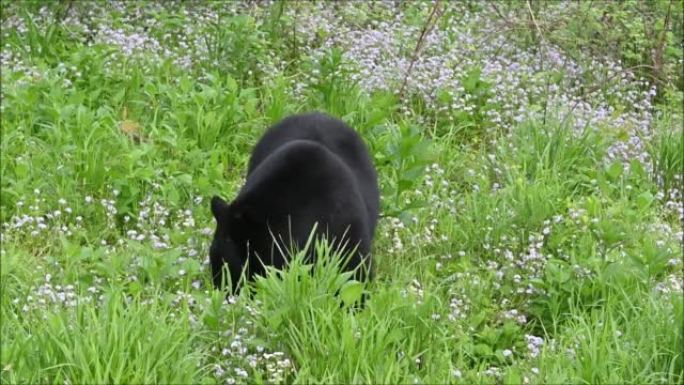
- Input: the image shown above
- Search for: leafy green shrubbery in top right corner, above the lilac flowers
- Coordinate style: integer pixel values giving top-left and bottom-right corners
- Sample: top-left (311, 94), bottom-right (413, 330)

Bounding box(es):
top-left (502, 0), bottom-right (684, 97)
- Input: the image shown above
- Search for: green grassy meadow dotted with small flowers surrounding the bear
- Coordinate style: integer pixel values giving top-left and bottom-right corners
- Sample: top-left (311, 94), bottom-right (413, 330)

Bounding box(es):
top-left (0, 3), bottom-right (684, 384)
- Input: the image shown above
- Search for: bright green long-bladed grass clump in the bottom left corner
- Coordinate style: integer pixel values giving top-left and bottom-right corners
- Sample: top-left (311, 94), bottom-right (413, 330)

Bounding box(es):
top-left (2, 289), bottom-right (201, 383)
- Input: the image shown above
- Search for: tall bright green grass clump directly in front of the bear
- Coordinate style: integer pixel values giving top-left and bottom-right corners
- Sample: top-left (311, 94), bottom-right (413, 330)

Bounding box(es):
top-left (254, 244), bottom-right (450, 383)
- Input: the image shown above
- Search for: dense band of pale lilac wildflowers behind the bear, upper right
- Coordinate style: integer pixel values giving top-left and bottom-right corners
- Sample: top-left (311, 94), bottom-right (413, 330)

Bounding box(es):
top-left (288, 3), bottom-right (655, 148)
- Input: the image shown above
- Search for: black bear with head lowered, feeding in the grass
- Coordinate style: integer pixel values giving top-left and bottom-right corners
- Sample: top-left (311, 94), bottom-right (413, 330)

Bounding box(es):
top-left (209, 113), bottom-right (380, 291)
